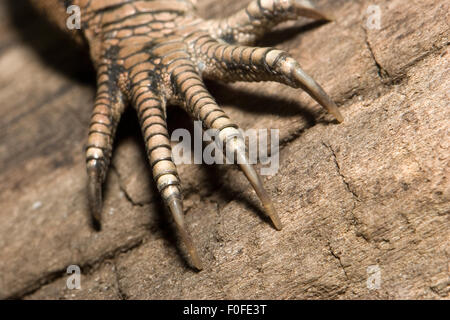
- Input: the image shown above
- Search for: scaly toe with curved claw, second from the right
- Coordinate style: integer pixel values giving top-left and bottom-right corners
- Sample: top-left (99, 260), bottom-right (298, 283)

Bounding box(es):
top-left (202, 42), bottom-right (344, 122)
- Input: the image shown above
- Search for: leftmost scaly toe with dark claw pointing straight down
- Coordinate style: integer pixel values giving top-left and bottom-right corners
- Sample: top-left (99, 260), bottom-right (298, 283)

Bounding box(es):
top-left (86, 66), bottom-right (125, 227)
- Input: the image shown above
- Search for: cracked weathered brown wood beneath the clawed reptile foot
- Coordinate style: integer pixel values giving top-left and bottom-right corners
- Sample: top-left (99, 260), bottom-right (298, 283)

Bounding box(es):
top-left (0, 0), bottom-right (450, 299)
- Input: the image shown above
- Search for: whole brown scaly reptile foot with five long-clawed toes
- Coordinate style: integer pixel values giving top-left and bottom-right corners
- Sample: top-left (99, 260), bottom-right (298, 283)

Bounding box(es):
top-left (31, 0), bottom-right (343, 270)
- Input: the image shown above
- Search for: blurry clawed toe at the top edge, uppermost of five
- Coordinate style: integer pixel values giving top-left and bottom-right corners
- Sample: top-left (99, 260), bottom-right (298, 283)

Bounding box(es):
top-left (211, 0), bottom-right (330, 45)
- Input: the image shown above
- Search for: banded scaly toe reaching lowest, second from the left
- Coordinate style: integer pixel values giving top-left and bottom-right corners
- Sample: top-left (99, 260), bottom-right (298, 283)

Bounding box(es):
top-left (133, 87), bottom-right (202, 270)
